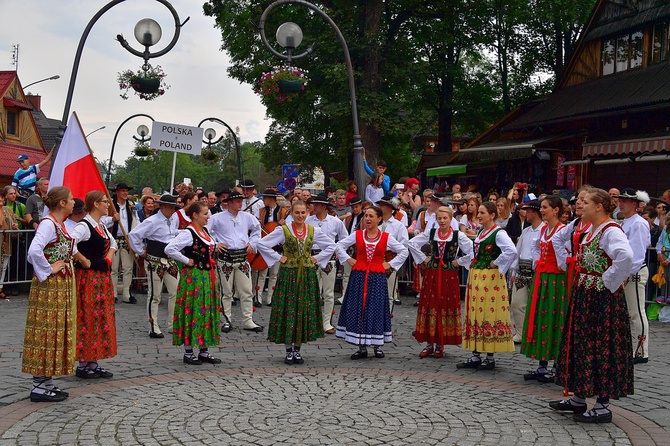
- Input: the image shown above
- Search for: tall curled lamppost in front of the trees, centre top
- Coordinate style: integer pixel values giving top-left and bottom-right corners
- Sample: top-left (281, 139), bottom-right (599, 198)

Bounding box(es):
top-left (258, 0), bottom-right (365, 197)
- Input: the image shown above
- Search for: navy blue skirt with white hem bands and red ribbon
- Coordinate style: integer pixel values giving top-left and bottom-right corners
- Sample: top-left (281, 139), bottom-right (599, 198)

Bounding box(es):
top-left (335, 271), bottom-right (393, 345)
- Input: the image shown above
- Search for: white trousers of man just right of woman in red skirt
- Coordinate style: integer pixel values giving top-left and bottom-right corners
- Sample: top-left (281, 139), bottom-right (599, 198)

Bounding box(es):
top-left (144, 259), bottom-right (179, 333)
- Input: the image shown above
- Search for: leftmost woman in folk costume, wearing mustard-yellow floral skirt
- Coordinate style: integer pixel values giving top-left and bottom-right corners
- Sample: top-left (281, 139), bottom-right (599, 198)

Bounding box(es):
top-left (22, 186), bottom-right (91, 402)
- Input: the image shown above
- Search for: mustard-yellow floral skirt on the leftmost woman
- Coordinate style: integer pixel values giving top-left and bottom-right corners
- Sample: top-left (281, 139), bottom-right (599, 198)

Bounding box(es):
top-left (22, 275), bottom-right (77, 376)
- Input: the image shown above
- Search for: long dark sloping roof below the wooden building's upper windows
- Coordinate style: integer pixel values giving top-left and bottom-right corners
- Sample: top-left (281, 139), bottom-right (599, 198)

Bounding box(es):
top-left (504, 62), bottom-right (670, 130)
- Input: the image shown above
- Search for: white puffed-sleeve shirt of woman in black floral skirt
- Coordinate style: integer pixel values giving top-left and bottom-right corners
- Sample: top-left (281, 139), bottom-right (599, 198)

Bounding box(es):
top-left (582, 221), bottom-right (633, 292)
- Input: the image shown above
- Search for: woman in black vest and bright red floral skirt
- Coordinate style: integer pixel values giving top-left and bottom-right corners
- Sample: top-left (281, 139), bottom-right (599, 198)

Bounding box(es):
top-left (72, 190), bottom-right (117, 379)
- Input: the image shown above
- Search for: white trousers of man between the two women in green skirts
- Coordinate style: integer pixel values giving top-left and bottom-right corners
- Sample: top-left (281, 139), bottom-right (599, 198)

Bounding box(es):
top-left (216, 261), bottom-right (258, 328)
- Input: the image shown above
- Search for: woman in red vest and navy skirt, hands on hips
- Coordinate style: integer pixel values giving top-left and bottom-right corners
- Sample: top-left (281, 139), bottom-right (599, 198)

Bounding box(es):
top-left (336, 206), bottom-right (409, 359)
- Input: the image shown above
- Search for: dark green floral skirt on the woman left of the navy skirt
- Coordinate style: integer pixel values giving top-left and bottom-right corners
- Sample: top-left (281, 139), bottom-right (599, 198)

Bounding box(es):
top-left (268, 266), bottom-right (324, 344)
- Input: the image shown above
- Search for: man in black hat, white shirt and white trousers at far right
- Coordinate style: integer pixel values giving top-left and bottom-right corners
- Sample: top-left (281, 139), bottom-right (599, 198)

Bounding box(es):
top-left (616, 188), bottom-right (651, 364)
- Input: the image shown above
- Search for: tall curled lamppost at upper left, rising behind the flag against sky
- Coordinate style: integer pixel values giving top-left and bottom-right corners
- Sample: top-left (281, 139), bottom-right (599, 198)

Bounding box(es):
top-left (55, 0), bottom-right (190, 153)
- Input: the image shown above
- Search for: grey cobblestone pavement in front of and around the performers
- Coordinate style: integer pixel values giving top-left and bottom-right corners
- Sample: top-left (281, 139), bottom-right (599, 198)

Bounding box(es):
top-left (0, 295), bottom-right (670, 446)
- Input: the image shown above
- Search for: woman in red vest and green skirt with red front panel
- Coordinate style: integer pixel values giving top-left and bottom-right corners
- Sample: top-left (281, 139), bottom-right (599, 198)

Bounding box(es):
top-left (521, 195), bottom-right (568, 382)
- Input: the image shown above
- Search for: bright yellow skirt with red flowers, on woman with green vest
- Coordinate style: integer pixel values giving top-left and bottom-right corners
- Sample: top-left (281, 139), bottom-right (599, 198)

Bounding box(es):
top-left (463, 268), bottom-right (514, 353)
